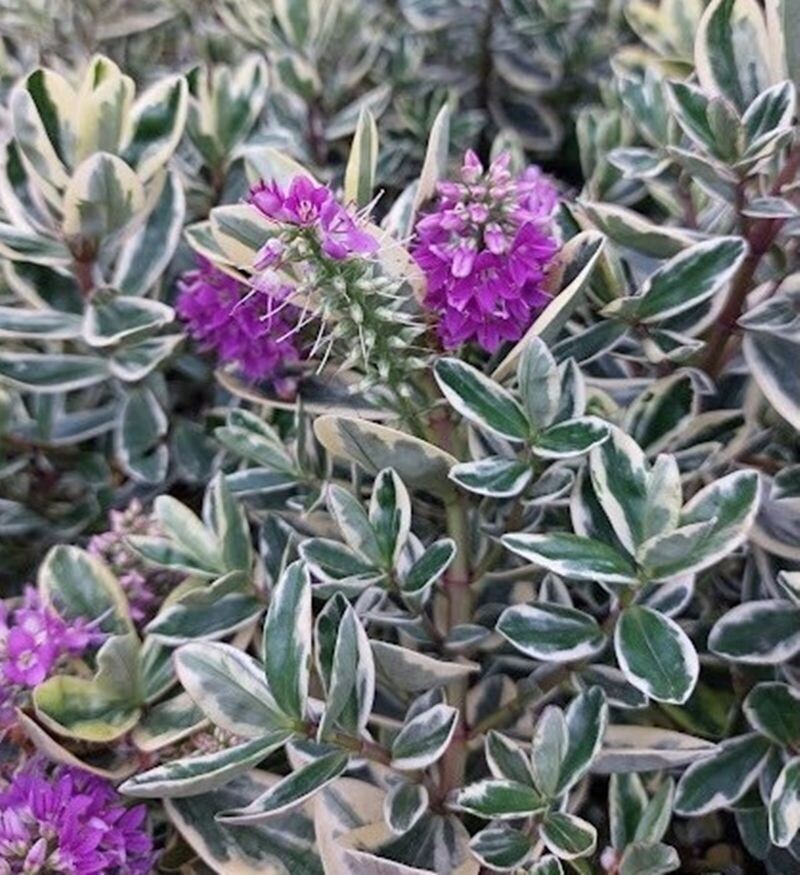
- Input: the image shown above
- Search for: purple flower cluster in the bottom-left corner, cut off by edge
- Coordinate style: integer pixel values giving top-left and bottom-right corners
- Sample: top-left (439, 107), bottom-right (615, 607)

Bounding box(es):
top-left (0, 760), bottom-right (154, 875)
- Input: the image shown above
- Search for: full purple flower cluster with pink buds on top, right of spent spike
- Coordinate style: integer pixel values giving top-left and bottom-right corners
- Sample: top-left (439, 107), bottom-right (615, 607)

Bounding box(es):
top-left (412, 151), bottom-right (558, 352)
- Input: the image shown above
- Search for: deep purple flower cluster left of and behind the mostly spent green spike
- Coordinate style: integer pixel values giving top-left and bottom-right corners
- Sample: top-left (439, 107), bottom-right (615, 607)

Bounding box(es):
top-left (177, 258), bottom-right (299, 391)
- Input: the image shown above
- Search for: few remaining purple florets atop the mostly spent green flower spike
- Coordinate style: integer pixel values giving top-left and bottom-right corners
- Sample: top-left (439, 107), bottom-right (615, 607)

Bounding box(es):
top-left (250, 175), bottom-right (378, 270)
